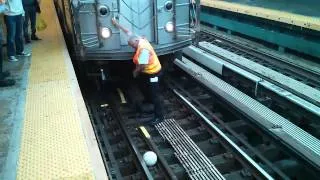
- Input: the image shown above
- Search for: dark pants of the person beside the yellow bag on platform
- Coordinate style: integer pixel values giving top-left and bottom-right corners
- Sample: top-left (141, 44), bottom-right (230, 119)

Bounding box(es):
top-left (23, 6), bottom-right (37, 39)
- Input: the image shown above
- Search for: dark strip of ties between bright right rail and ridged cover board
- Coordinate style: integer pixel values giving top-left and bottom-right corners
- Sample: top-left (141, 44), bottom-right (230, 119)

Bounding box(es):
top-left (165, 68), bottom-right (316, 179)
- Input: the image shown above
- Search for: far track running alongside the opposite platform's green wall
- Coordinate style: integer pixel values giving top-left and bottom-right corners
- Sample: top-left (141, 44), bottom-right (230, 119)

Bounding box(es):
top-left (200, 28), bottom-right (320, 89)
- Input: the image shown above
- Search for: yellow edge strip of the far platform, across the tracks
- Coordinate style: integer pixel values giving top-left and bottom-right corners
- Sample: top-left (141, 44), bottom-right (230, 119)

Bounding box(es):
top-left (201, 0), bottom-right (320, 31)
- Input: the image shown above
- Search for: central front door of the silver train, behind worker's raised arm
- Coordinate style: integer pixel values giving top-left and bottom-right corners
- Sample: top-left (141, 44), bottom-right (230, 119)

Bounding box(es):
top-left (119, 0), bottom-right (154, 45)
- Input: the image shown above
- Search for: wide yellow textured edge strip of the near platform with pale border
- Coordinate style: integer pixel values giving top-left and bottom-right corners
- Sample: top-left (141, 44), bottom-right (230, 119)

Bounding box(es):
top-left (17, 1), bottom-right (107, 180)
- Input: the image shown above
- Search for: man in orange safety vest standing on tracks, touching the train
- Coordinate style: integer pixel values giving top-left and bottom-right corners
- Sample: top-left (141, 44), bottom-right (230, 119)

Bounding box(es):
top-left (112, 18), bottom-right (164, 125)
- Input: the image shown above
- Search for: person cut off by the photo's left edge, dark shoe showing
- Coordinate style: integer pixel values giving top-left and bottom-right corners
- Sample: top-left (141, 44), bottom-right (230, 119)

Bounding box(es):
top-left (0, 0), bottom-right (15, 87)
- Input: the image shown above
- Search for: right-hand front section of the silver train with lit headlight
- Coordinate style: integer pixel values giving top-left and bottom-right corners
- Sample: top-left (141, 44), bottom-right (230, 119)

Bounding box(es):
top-left (155, 0), bottom-right (191, 44)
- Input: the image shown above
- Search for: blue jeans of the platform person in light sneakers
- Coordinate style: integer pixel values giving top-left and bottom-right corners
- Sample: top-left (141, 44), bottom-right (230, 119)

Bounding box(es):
top-left (4, 15), bottom-right (24, 56)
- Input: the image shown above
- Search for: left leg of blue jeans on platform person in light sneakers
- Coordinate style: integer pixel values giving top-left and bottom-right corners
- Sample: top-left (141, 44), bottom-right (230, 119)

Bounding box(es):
top-left (4, 16), bottom-right (16, 58)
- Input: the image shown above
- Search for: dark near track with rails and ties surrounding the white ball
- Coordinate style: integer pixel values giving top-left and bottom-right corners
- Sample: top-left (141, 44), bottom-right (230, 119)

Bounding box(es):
top-left (81, 63), bottom-right (316, 179)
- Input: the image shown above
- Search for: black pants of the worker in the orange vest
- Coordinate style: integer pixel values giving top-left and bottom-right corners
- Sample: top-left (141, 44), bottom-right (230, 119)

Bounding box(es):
top-left (138, 71), bottom-right (164, 118)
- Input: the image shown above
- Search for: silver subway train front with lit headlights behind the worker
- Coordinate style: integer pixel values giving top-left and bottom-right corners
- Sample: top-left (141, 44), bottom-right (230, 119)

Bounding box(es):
top-left (55, 0), bottom-right (199, 61)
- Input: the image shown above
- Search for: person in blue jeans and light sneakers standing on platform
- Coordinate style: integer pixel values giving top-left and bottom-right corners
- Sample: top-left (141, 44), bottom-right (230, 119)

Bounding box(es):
top-left (4, 0), bottom-right (30, 62)
